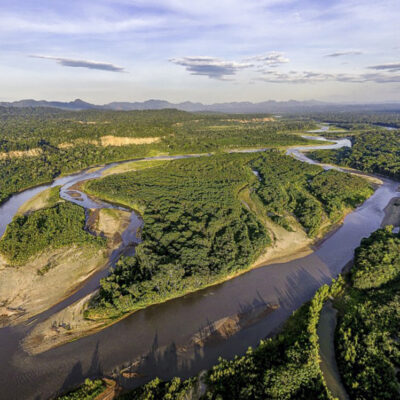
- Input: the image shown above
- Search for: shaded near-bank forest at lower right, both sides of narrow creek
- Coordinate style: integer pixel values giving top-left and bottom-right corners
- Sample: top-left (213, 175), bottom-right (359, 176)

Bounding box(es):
top-left (116, 226), bottom-right (400, 400)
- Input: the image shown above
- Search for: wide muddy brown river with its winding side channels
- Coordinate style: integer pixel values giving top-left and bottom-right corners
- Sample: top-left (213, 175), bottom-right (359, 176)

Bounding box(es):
top-left (0, 132), bottom-right (398, 400)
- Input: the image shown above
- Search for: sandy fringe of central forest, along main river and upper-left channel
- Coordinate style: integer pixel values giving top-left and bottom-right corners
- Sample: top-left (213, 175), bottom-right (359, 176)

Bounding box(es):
top-left (19, 140), bottom-right (378, 354)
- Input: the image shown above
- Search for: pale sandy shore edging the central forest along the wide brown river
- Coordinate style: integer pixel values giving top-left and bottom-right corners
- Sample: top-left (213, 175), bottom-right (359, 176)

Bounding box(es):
top-left (23, 177), bottom-right (374, 355)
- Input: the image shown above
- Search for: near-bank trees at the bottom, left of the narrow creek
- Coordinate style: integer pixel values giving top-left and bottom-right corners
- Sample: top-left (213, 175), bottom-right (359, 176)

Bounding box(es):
top-left (121, 277), bottom-right (344, 400)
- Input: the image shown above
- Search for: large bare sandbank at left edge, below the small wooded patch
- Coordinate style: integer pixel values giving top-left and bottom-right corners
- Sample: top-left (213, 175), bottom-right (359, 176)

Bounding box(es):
top-left (0, 246), bottom-right (107, 326)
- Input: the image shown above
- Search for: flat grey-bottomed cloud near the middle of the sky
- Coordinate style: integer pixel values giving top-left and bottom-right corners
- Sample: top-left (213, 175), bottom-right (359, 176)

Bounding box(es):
top-left (169, 56), bottom-right (252, 80)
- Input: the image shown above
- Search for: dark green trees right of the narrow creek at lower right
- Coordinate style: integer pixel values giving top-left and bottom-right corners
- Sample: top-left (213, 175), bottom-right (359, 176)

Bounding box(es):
top-left (336, 227), bottom-right (400, 400)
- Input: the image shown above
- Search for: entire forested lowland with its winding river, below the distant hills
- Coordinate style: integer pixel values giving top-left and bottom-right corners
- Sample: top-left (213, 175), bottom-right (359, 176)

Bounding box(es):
top-left (0, 107), bottom-right (400, 400)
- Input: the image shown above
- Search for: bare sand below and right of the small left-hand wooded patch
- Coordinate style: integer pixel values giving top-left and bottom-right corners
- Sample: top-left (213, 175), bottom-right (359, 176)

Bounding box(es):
top-left (0, 206), bottom-right (130, 326)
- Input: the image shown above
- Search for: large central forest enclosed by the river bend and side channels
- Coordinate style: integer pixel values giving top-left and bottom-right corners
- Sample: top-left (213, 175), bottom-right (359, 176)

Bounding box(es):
top-left (86, 151), bottom-right (373, 318)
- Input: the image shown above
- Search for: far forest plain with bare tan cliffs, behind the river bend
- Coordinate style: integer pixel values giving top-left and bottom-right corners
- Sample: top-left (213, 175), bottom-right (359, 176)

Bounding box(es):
top-left (0, 107), bottom-right (315, 203)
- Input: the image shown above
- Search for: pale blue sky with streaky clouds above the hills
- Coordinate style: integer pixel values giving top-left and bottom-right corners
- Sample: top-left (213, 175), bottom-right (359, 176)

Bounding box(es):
top-left (0, 0), bottom-right (400, 104)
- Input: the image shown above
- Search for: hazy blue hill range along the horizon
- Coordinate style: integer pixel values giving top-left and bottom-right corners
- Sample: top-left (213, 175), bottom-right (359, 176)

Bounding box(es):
top-left (0, 99), bottom-right (400, 114)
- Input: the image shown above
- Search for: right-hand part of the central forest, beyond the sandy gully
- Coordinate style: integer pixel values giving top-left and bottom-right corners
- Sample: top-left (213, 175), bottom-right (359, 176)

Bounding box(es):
top-left (252, 152), bottom-right (372, 237)
